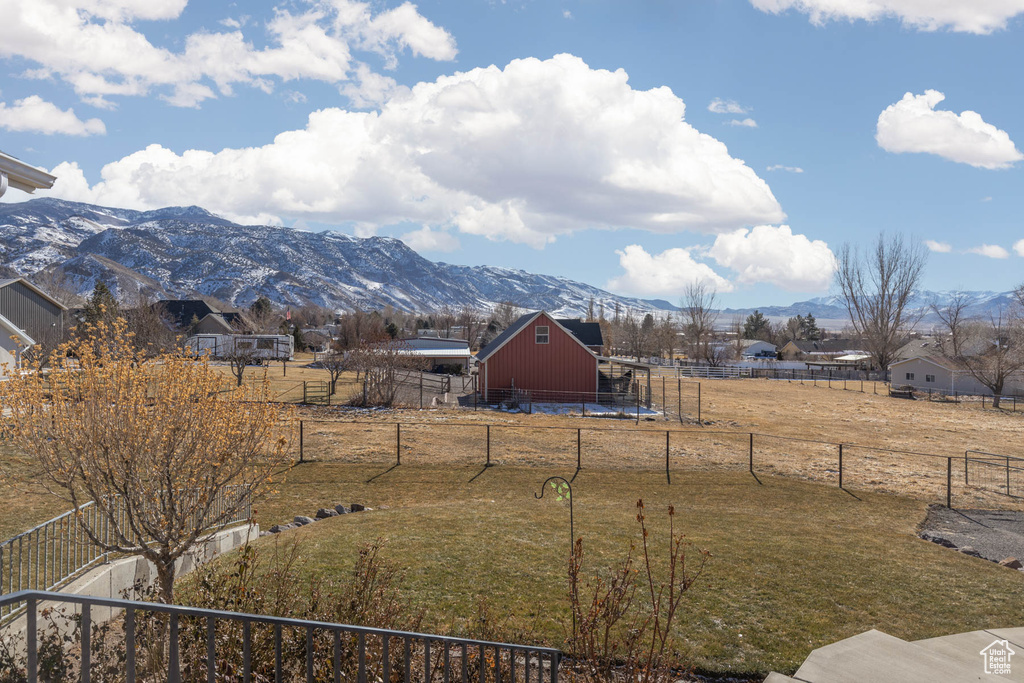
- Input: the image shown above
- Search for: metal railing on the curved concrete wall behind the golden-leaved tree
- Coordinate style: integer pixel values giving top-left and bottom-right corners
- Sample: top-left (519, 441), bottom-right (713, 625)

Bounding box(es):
top-left (0, 487), bottom-right (252, 624)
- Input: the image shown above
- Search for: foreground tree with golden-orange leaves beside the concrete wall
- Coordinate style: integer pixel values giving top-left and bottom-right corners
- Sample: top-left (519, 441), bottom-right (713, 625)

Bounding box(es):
top-left (0, 319), bottom-right (287, 602)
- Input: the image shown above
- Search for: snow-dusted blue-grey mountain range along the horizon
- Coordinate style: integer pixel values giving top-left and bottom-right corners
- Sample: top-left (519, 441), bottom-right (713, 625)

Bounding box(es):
top-left (0, 199), bottom-right (1012, 327)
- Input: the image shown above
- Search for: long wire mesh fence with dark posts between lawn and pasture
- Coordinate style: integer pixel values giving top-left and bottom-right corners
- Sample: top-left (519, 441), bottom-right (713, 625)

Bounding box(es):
top-left (290, 420), bottom-right (1024, 506)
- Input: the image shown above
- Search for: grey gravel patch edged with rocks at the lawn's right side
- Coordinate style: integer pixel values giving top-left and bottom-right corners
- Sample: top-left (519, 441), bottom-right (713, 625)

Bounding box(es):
top-left (920, 506), bottom-right (1024, 562)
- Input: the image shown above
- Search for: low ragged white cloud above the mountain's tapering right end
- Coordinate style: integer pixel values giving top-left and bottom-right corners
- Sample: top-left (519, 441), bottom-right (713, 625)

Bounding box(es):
top-left (607, 245), bottom-right (732, 297)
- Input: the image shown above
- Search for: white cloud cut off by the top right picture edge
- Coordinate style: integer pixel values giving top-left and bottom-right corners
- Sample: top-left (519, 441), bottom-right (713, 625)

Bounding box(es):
top-left (751, 0), bottom-right (1024, 34)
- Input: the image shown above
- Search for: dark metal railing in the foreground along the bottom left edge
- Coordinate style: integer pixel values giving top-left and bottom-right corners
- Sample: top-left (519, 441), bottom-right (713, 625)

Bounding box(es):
top-left (0, 591), bottom-right (561, 683)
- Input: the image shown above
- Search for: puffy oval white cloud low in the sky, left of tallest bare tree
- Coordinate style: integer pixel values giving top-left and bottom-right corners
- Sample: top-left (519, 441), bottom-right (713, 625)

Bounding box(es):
top-left (708, 225), bottom-right (836, 292)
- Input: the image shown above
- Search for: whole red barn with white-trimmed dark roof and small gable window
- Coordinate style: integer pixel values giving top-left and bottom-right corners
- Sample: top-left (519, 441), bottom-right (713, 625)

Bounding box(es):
top-left (477, 310), bottom-right (601, 401)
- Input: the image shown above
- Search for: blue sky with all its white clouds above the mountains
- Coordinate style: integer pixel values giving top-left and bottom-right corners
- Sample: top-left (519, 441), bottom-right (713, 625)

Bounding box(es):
top-left (0, 0), bottom-right (1024, 306)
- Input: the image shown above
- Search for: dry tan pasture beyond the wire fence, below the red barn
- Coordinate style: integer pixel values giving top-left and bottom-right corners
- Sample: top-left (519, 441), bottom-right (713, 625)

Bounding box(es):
top-left (288, 380), bottom-right (1024, 507)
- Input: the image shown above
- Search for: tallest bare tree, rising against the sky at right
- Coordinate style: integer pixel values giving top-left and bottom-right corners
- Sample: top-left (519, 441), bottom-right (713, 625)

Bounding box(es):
top-left (836, 234), bottom-right (928, 370)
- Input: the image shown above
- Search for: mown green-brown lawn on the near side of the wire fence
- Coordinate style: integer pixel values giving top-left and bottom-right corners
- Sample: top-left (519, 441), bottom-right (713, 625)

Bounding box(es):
top-left (249, 463), bottom-right (1024, 676)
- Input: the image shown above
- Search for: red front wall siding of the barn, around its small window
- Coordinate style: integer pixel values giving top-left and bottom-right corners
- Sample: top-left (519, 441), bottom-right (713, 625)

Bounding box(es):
top-left (483, 314), bottom-right (597, 401)
